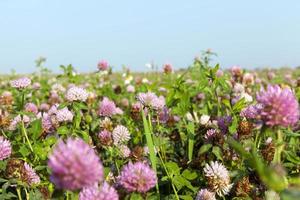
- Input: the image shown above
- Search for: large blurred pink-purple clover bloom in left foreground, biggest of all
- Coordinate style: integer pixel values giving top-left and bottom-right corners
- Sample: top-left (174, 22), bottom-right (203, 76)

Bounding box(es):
top-left (48, 138), bottom-right (103, 190)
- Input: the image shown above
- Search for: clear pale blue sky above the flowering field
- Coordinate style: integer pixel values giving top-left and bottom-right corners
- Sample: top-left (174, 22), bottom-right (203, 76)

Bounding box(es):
top-left (0, 0), bottom-right (300, 73)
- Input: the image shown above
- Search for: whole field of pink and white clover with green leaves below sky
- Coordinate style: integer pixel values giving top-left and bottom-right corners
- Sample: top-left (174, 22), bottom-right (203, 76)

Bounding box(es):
top-left (0, 51), bottom-right (300, 200)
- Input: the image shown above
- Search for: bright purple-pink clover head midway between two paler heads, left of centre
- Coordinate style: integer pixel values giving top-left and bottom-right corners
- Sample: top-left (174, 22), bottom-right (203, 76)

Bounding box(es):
top-left (98, 97), bottom-right (123, 117)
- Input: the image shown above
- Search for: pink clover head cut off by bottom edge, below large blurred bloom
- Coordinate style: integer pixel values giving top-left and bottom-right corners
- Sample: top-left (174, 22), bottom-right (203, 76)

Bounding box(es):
top-left (79, 182), bottom-right (119, 200)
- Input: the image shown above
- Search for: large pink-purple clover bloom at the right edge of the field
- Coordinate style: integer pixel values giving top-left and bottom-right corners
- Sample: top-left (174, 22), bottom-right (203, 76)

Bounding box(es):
top-left (256, 85), bottom-right (299, 127)
